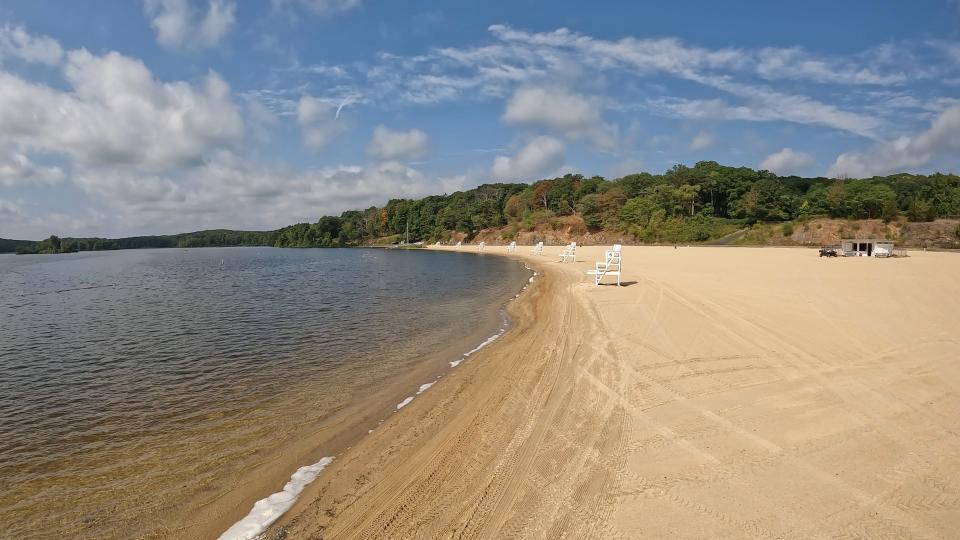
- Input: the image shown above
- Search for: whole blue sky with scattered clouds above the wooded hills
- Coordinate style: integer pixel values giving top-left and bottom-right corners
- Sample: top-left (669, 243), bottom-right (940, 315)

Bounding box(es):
top-left (0, 0), bottom-right (960, 238)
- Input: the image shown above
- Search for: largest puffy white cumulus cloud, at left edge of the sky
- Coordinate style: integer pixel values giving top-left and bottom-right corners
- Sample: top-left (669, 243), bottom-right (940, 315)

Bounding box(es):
top-left (0, 50), bottom-right (244, 168)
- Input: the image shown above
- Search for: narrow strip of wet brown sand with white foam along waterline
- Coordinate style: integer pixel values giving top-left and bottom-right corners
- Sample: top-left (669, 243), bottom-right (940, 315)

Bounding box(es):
top-left (187, 253), bottom-right (535, 539)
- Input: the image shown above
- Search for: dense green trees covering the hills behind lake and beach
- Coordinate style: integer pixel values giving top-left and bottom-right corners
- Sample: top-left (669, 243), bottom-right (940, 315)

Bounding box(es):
top-left (7, 161), bottom-right (960, 252)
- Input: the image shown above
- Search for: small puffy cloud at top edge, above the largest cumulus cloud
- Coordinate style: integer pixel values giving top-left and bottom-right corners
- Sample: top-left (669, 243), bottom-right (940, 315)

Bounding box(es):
top-left (144, 0), bottom-right (237, 48)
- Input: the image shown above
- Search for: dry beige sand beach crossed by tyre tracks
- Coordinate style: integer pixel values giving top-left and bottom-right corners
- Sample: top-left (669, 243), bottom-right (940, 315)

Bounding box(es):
top-left (269, 246), bottom-right (960, 538)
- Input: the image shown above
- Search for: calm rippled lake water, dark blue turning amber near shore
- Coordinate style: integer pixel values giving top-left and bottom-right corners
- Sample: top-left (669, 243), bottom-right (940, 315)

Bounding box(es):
top-left (0, 248), bottom-right (529, 538)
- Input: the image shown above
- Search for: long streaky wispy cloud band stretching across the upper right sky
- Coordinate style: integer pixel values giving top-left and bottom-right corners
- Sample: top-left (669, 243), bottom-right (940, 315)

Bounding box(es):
top-left (249, 25), bottom-right (960, 139)
